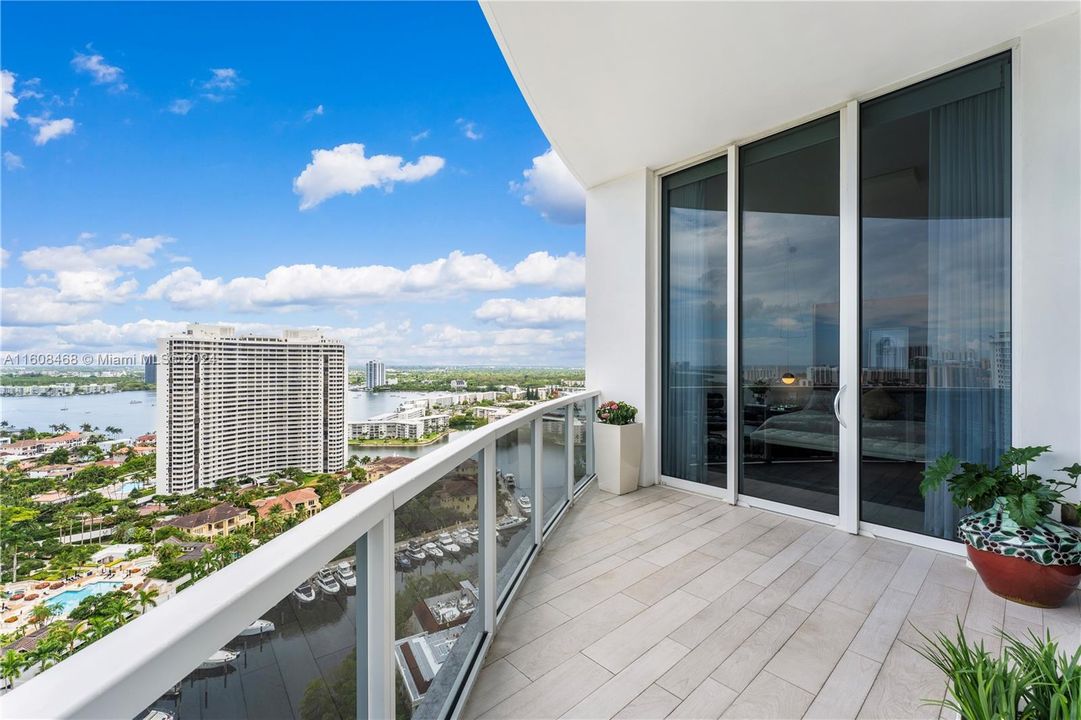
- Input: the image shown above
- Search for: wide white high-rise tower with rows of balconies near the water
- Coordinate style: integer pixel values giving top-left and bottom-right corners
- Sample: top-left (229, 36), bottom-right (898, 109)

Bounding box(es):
top-left (157, 324), bottom-right (347, 494)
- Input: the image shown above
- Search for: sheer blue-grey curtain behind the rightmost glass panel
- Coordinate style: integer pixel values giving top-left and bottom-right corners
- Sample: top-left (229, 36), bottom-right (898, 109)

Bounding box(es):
top-left (923, 86), bottom-right (1011, 531)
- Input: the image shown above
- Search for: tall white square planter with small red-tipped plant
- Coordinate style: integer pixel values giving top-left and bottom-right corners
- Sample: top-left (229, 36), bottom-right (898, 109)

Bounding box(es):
top-left (593, 401), bottom-right (642, 495)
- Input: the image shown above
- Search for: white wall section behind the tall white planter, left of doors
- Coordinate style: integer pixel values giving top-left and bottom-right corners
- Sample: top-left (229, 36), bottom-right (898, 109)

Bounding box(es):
top-left (586, 170), bottom-right (657, 485)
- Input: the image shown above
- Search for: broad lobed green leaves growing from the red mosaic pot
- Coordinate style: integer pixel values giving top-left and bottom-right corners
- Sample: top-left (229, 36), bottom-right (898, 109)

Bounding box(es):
top-left (920, 445), bottom-right (1081, 528)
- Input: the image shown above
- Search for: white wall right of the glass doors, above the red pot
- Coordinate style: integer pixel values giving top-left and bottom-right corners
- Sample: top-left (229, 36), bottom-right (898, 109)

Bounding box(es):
top-left (1013, 14), bottom-right (1081, 497)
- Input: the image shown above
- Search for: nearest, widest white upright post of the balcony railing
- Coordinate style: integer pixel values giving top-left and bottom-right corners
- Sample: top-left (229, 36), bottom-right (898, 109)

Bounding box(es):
top-left (365, 512), bottom-right (396, 720)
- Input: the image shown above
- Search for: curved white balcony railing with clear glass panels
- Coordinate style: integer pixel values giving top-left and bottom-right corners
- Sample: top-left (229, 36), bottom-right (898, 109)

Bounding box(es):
top-left (0, 391), bottom-right (597, 720)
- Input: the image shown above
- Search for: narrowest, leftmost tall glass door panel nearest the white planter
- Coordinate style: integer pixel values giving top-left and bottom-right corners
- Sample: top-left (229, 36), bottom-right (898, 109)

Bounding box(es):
top-left (660, 158), bottom-right (728, 488)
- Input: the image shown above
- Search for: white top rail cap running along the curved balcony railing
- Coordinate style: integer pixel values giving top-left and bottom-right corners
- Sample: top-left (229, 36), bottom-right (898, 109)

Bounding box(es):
top-left (0, 390), bottom-right (599, 720)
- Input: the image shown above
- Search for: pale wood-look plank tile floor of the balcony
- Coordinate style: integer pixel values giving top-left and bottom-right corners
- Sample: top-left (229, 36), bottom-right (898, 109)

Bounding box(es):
top-left (477, 488), bottom-right (1081, 718)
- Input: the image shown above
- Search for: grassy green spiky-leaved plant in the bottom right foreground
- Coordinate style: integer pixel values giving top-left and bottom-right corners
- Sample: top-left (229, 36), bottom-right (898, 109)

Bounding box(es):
top-left (912, 619), bottom-right (1030, 720)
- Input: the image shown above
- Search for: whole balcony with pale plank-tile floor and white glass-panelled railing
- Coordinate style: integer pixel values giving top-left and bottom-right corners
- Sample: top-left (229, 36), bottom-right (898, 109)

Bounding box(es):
top-left (0, 391), bottom-right (1081, 719)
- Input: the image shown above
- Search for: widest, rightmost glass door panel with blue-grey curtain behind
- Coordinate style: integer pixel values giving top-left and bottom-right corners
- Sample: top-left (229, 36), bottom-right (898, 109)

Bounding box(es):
top-left (859, 54), bottom-right (1011, 539)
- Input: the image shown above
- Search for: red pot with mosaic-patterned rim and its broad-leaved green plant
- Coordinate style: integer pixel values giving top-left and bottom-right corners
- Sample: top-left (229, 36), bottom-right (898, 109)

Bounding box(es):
top-left (920, 445), bottom-right (1081, 608)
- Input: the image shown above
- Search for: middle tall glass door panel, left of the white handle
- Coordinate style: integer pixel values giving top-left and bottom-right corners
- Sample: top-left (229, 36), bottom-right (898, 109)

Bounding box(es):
top-left (739, 115), bottom-right (840, 515)
